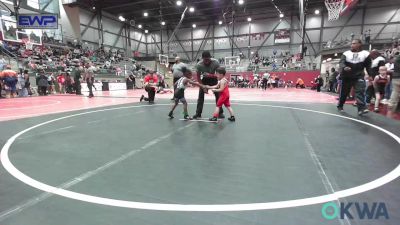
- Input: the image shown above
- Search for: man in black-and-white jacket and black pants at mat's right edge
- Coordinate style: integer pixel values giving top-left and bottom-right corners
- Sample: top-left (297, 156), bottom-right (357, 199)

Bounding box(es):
top-left (337, 39), bottom-right (371, 116)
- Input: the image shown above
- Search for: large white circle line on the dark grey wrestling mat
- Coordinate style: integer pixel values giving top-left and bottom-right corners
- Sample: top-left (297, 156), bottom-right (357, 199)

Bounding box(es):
top-left (0, 103), bottom-right (400, 212)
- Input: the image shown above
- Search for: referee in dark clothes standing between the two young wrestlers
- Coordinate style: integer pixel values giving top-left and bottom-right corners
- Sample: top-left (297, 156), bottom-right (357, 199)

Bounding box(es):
top-left (193, 51), bottom-right (225, 119)
